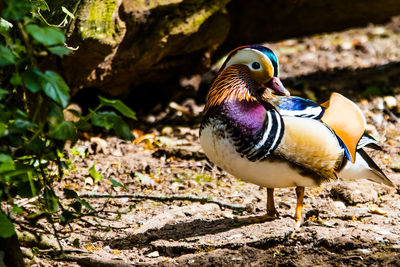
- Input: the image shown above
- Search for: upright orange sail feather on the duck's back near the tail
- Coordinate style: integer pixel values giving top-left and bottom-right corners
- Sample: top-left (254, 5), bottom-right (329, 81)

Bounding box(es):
top-left (321, 93), bottom-right (366, 163)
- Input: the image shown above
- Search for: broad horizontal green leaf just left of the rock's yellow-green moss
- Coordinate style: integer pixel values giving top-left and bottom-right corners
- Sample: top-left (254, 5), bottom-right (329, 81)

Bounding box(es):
top-left (26, 24), bottom-right (65, 46)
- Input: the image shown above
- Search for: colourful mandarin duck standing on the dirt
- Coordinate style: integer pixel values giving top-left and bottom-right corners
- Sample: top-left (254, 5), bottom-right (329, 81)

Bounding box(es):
top-left (200, 45), bottom-right (393, 227)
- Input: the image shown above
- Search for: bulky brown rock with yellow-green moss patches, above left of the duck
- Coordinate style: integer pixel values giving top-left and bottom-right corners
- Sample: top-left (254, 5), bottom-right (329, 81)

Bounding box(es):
top-left (62, 0), bottom-right (230, 106)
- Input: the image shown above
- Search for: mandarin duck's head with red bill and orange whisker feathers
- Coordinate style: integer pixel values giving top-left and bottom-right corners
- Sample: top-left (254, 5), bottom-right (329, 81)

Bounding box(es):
top-left (206, 45), bottom-right (290, 110)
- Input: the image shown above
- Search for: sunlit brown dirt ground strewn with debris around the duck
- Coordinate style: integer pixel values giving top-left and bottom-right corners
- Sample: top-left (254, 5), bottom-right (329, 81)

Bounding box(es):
top-left (21, 17), bottom-right (400, 266)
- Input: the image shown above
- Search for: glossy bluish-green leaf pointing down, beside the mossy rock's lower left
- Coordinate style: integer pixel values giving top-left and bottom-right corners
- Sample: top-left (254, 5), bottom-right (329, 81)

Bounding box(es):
top-left (42, 70), bottom-right (70, 108)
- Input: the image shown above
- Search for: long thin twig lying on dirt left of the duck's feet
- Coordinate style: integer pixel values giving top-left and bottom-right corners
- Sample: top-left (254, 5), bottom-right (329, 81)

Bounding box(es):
top-left (79, 194), bottom-right (246, 211)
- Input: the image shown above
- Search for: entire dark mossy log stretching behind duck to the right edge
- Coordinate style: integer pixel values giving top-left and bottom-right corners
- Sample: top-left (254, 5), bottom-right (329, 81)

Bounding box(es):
top-left (43, 0), bottom-right (400, 109)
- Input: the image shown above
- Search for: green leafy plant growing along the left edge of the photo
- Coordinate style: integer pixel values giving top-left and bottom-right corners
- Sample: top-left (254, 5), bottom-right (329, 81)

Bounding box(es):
top-left (0, 0), bottom-right (136, 260)
